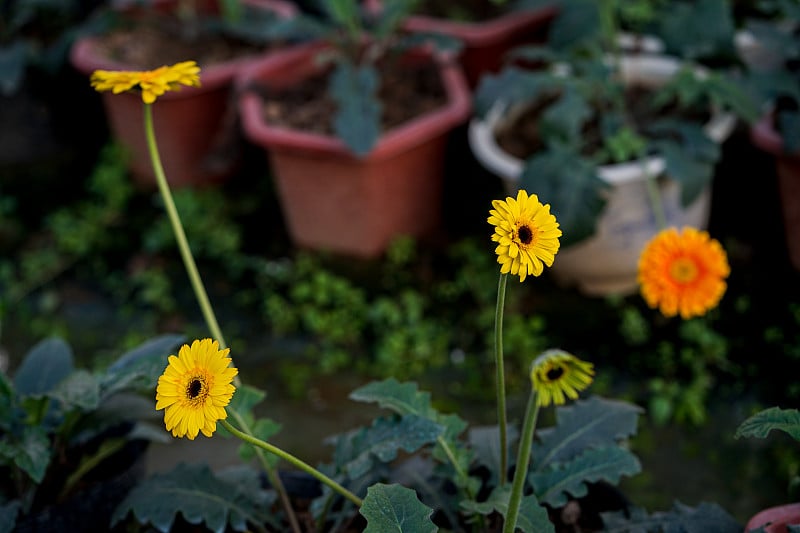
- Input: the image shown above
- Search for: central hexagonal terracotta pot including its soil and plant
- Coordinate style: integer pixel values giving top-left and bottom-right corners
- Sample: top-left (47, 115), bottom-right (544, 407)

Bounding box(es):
top-left (233, 2), bottom-right (470, 258)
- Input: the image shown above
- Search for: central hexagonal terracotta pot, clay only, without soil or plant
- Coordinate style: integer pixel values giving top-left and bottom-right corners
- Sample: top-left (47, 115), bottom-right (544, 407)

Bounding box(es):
top-left (238, 42), bottom-right (471, 257)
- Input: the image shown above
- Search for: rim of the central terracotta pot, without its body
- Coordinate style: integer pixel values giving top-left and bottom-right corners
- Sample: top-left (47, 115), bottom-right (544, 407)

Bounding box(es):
top-left (236, 43), bottom-right (472, 161)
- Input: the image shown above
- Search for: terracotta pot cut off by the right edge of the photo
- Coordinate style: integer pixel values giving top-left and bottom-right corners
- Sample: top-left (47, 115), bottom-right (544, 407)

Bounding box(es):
top-left (750, 113), bottom-right (800, 270)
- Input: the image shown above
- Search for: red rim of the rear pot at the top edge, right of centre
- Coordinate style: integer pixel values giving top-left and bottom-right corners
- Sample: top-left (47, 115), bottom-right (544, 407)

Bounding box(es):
top-left (405, 4), bottom-right (558, 47)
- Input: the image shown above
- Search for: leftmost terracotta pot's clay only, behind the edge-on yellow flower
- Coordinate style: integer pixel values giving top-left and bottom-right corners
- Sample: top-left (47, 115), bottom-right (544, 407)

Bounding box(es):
top-left (70, 0), bottom-right (296, 189)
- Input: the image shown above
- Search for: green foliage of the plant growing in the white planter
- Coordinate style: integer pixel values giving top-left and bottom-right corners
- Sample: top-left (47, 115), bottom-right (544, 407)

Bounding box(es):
top-left (475, 0), bottom-right (757, 246)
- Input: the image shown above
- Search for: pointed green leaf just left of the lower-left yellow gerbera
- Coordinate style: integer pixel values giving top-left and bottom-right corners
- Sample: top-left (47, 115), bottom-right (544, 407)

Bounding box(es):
top-left (101, 335), bottom-right (185, 398)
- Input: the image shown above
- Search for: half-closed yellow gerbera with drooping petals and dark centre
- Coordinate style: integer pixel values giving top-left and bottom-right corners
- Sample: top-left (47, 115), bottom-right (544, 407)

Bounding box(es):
top-left (531, 350), bottom-right (594, 407)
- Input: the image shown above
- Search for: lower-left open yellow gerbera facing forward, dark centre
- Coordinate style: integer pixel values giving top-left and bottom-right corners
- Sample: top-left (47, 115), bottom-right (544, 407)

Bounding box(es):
top-left (156, 339), bottom-right (239, 440)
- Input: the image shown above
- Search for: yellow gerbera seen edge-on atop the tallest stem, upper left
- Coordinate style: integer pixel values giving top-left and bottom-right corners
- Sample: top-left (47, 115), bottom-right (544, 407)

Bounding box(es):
top-left (90, 61), bottom-right (200, 104)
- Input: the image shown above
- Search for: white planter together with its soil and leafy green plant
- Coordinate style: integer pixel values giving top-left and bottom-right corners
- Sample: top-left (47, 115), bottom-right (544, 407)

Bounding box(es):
top-left (469, 0), bottom-right (752, 296)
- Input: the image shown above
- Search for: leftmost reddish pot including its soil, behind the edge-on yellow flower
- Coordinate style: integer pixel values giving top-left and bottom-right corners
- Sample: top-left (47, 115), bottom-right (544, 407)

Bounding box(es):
top-left (70, 0), bottom-right (296, 189)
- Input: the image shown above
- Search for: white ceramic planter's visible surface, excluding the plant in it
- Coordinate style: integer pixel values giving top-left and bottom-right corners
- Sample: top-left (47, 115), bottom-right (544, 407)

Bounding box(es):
top-left (468, 55), bottom-right (736, 296)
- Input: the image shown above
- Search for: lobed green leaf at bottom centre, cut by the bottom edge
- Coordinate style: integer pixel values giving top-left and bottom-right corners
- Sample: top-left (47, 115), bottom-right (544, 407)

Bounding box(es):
top-left (359, 483), bottom-right (438, 533)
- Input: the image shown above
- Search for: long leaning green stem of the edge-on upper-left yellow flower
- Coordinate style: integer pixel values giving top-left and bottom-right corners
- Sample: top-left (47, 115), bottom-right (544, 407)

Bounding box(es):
top-left (144, 104), bottom-right (300, 533)
